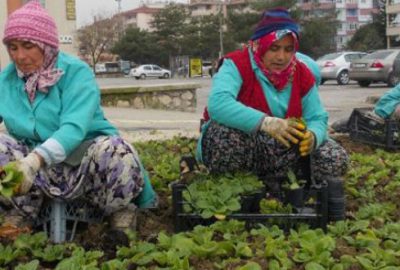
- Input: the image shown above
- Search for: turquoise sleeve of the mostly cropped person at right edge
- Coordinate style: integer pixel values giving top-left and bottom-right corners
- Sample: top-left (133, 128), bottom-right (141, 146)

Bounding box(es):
top-left (374, 84), bottom-right (400, 119)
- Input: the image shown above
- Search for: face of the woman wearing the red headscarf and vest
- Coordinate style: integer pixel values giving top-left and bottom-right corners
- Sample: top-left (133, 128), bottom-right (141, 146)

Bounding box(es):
top-left (262, 35), bottom-right (295, 72)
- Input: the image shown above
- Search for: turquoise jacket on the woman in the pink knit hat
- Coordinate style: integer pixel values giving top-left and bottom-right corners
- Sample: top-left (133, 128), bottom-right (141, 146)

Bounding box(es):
top-left (0, 52), bottom-right (118, 161)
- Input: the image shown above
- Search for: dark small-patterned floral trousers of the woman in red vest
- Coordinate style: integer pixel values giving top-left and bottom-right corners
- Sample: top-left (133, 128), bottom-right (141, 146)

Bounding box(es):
top-left (202, 122), bottom-right (349, 181)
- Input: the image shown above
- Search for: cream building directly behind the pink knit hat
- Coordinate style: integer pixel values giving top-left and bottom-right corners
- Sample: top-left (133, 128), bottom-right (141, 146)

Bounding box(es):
top-left (0, 0), bottom-right (78, 68)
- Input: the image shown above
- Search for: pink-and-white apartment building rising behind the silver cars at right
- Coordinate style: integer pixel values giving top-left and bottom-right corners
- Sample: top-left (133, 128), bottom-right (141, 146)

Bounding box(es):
top-left (298, 0), bottom-right (378, 51)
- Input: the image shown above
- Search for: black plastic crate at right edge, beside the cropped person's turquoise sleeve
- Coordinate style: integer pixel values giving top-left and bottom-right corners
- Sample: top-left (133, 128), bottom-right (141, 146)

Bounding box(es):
top-left (348, 108), bottom-right (400, 150)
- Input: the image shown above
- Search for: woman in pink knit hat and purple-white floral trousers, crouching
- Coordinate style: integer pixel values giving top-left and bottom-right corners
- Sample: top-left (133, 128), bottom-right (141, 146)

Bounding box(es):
top-left (0, 0), bottom-right (156, 229)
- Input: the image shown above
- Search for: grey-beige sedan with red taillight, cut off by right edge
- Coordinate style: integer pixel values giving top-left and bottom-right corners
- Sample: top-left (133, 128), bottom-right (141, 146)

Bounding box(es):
top-left (349, 49), bottom-right (400, 87)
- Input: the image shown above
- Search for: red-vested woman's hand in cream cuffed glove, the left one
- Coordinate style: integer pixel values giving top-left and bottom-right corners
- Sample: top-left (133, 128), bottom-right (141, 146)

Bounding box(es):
top-left (260, 116), bottom-right (306, 148)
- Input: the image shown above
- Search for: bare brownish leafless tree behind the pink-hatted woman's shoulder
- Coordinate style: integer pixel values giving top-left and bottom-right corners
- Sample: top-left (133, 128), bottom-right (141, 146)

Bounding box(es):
top-left (77, 16), bottom-right (119, 71)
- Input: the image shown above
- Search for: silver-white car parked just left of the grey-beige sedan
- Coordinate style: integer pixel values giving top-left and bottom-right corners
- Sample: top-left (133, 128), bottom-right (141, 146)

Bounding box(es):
top-left (317, 52), bottom-right (367, 85)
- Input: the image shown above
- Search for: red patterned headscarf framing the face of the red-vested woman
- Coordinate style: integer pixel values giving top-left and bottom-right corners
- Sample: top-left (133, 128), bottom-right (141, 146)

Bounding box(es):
top-left (250, 29), bottom-right (299, 90)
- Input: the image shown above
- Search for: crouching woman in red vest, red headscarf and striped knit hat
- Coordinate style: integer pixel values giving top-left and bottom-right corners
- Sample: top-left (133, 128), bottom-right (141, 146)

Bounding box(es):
top-left (198, 8), bottom-right (348, 220)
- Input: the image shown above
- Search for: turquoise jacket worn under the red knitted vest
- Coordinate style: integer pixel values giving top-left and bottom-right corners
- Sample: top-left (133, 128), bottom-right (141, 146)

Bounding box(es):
top-left (197, 48), bottom-right (328, 161)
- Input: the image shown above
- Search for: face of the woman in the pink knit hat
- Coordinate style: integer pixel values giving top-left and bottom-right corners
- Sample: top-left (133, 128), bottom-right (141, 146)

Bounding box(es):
top-left (7, 40), bottom-right (44, 74)
